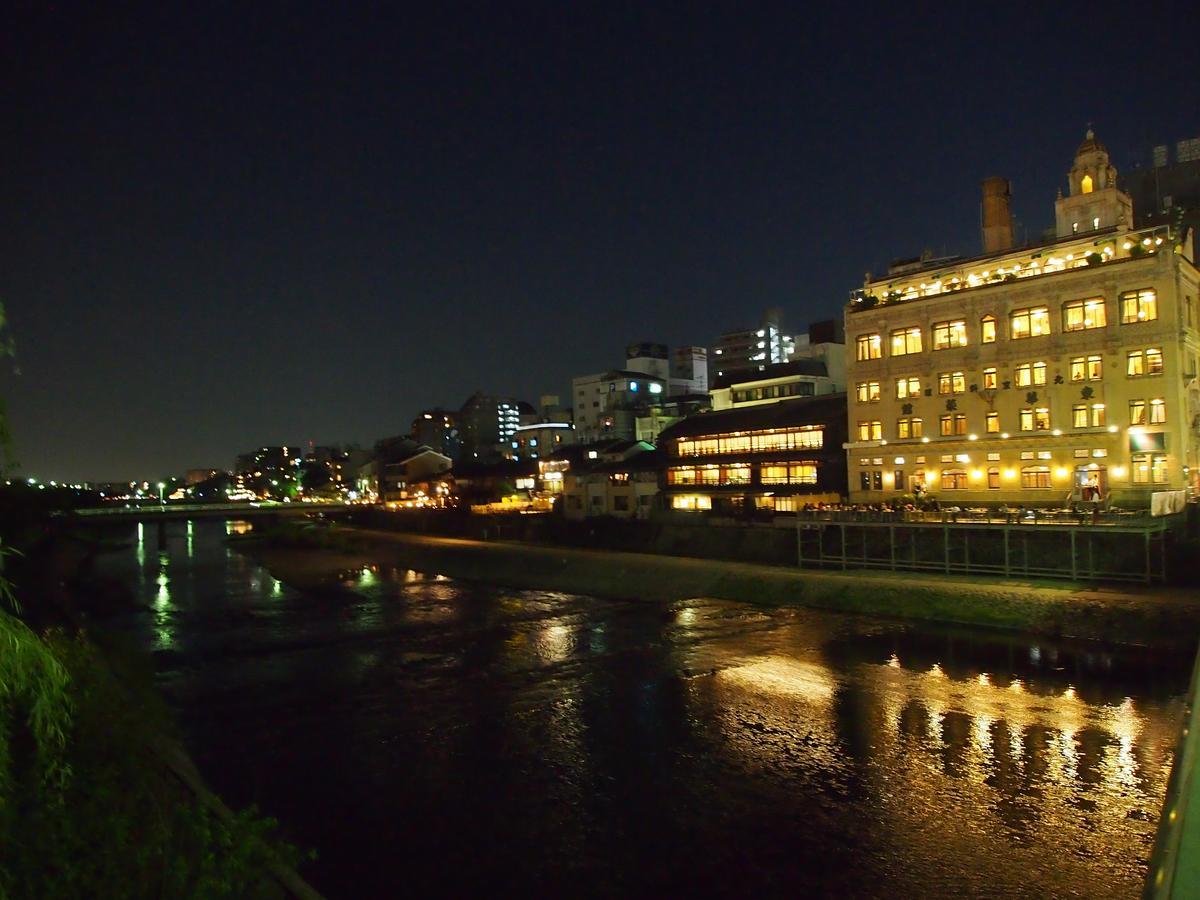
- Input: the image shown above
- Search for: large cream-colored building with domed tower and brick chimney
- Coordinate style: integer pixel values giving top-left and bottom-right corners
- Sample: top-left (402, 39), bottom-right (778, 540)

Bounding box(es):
top-left (846, 132), bottom-right (1200, 508)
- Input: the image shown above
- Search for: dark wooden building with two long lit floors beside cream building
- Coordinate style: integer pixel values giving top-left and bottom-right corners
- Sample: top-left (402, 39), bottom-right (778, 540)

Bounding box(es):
top-left (659, 394), bottom-right (846, 515)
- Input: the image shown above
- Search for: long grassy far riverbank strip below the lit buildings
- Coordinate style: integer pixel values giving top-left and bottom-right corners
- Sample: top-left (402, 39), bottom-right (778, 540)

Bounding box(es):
top-left (238, 527), bottom-right (1200, 647)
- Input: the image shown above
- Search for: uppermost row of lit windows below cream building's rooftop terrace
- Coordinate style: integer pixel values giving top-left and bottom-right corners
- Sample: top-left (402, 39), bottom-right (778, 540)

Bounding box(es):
top-left (854, 288), bottom-right (1158, 361)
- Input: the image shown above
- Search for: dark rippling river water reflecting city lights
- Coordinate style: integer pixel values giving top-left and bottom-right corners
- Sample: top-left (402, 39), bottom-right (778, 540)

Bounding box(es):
top-left (98, 521), bottom-right (1190, 898)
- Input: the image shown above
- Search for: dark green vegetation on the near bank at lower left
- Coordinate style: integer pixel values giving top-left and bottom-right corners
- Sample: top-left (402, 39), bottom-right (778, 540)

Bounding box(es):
top-left (0, 491), bottom-right (301, 898)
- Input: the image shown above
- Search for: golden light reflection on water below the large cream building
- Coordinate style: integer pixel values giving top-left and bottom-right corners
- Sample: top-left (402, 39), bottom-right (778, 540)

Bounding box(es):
top-left (692, 628), bottom-right (1177, 895)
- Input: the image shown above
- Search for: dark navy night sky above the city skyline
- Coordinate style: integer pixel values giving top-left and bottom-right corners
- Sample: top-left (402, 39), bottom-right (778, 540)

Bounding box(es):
top-left (0, 2), bottom-right (1200, 480)
